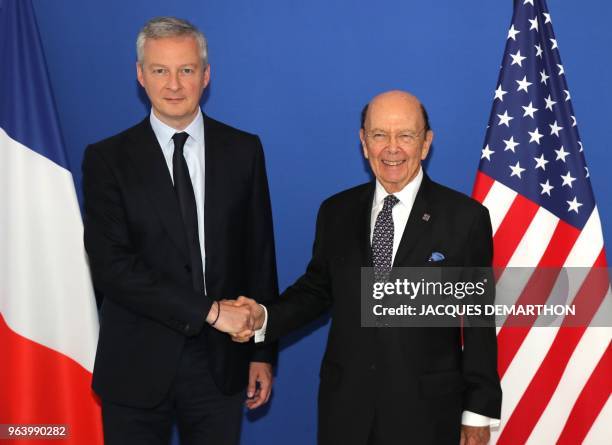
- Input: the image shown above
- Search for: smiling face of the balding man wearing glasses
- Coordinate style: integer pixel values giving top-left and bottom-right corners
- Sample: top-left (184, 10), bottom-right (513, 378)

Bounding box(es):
top-left (359, 91), bottom-right (433, 193)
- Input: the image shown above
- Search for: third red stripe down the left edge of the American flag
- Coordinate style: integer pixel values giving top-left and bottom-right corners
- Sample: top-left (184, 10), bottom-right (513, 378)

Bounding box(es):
top-left (495, 220), bottom-right (580, 377)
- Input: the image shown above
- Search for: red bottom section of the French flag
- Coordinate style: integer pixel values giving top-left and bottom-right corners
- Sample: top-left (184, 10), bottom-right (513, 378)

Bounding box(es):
top-left (0, 314), bottom-right (103, 445)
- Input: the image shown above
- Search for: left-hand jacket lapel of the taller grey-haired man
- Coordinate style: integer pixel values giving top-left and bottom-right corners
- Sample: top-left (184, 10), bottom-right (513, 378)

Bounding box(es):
top-left (127, 117), bottom-right (189, 258)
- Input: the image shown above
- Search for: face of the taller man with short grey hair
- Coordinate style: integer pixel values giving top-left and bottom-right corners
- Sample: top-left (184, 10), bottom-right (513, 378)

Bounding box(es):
top-left (136, 36), bottom-right (210, 130)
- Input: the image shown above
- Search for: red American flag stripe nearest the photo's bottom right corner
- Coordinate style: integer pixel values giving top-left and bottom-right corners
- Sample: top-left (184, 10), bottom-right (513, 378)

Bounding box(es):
top-left (557, 343), bottom-right (612, 445)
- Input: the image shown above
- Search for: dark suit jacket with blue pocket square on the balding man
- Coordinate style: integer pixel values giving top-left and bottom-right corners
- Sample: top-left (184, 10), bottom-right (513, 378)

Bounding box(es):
top-left (266, 175), bottom-right (501, 445)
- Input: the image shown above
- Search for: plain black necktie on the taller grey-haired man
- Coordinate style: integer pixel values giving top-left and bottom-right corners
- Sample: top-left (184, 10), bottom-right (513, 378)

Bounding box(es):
top-left (172, 132), bottom-right (204, 291)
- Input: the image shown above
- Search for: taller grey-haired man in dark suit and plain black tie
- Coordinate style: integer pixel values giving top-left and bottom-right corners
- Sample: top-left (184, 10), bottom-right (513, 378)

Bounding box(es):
top-left (83, 17), bottom-right (278, 445)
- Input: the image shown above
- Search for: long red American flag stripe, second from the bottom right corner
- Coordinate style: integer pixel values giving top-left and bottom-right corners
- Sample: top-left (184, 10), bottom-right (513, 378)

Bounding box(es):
top-left (497, 250), bottom-right (609, 445)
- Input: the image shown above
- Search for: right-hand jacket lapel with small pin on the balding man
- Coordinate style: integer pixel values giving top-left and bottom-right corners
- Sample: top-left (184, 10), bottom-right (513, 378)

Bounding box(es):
top-left (393, 174), bottom-right (432, 267)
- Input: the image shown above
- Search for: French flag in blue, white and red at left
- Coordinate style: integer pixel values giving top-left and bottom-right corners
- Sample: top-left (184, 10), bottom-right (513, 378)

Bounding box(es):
top-left (0, 0), bottom-right (103, 445)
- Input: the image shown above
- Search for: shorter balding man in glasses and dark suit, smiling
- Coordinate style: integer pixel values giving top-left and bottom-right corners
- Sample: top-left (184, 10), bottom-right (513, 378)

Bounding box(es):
top-left (234, 91), bottom-right (501, 445)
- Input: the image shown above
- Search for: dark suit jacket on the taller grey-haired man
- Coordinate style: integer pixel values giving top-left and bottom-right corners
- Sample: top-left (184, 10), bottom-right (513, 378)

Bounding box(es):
top-left (83, 116), bottom-right (278, 407)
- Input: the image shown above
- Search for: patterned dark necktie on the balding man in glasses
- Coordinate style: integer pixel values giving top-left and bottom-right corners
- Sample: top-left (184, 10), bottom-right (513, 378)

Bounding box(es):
top-left (372, 195), bottom-right (399, 282)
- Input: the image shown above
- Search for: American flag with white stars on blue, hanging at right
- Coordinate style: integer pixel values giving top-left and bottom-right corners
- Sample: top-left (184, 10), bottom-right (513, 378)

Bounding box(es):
top-left (473, 0), bottom-right (612, 445)
